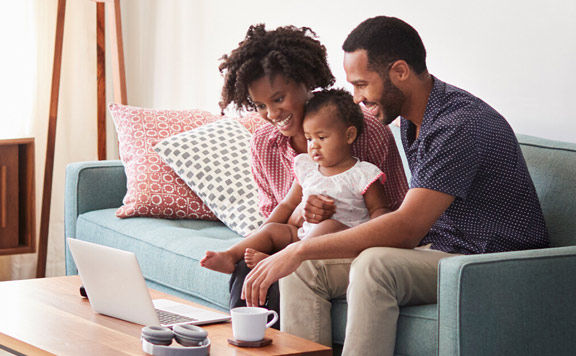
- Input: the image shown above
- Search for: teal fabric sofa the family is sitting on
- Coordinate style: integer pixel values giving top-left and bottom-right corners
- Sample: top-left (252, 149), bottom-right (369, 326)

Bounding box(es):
top-left (65, 128), bottom-right (576, 356)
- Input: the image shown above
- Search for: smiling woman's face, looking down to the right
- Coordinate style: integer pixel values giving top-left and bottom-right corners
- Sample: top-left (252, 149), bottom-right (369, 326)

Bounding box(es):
top-left (248, 74), bottom-right (312, 137)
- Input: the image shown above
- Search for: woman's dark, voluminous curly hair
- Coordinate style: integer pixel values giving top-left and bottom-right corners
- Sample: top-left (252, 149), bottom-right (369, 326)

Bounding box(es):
top-left (218, 24), bottom-right (334, 110)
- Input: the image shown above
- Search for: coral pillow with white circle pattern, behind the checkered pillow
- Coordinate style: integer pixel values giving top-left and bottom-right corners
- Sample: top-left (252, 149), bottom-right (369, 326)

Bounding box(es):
top-left (109, 104), bottom-right (262, 220)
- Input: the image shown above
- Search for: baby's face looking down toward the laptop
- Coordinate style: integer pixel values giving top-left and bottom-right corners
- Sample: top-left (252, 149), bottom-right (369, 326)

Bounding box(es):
top-left (303, 106), bottom-right (354, 167)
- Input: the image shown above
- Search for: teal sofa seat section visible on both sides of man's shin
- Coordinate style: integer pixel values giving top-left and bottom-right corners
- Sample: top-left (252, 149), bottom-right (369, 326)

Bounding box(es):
top-left (332, 300), bottom-right (438, 356)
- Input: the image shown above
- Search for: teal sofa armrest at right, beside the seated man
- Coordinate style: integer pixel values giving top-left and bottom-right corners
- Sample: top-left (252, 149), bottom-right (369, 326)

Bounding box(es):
top-left (438, 246), bottom-right (576, 356)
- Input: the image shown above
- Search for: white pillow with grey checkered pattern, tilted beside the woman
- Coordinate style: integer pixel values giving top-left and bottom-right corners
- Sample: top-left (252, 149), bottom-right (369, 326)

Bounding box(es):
top-left (154, 119), bottom-right (264, 236)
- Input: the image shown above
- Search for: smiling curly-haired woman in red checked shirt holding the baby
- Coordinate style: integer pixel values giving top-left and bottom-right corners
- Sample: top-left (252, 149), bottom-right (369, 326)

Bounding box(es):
top-left (219, 24), bottom-right (408, 328)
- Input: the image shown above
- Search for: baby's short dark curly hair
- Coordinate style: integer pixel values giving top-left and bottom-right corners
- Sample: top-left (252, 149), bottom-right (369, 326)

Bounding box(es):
top-left (306, 88), bottom-right (364, 137)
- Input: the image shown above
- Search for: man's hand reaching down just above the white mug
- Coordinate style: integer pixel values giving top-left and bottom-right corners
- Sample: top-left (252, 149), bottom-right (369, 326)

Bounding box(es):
top-left (242, 242), bottom-right (302, 307)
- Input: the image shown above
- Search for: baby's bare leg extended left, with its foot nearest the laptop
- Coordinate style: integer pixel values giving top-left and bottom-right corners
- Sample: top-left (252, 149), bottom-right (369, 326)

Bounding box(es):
top-left (200, 223), bottom-right (297, 273)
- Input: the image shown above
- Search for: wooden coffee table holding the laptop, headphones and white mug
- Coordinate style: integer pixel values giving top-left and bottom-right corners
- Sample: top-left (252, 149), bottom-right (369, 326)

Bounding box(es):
top-left (0, 276), bottom-right (332, 356)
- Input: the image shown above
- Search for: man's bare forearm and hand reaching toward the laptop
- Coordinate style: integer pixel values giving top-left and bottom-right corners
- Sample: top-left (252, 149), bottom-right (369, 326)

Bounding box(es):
top-left (242, 188), bottom-right (454, 306)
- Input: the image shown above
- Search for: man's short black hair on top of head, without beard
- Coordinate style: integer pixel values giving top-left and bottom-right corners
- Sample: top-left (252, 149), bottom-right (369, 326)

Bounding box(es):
top-left (342, 16), bottom-right (427, 74)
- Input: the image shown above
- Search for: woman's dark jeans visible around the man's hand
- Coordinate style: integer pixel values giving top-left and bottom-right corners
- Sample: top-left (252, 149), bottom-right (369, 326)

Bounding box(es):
top-left (229, 260), bottom-right (280, 330)
